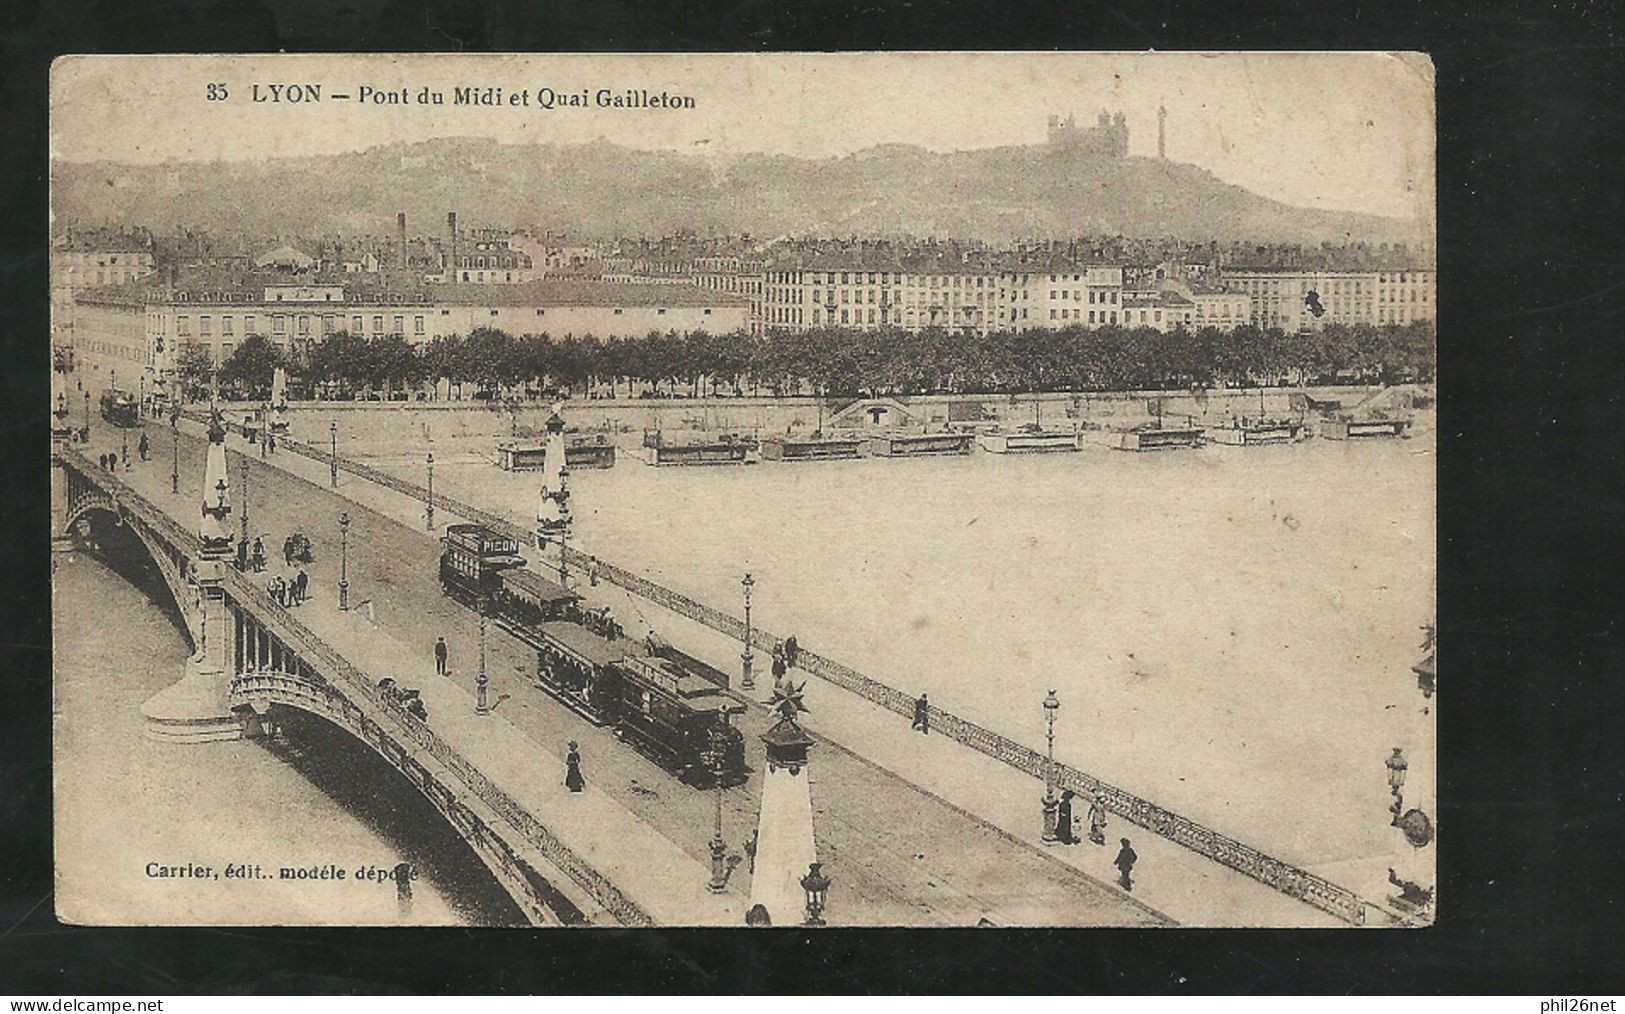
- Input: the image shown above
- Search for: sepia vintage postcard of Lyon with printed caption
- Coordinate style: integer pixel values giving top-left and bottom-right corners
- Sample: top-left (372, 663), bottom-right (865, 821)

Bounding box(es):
top-left (49, 54), bottom-right (1448, 928)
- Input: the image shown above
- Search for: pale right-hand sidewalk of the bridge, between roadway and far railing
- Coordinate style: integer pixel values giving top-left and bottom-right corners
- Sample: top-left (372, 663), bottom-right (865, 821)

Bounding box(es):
top-left (177, 424), bottom-right (1346, 926)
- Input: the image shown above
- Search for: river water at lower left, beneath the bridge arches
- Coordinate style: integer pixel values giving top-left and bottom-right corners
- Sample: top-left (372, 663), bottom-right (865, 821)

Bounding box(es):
top-left (54, 533), bottom-right (522, 925)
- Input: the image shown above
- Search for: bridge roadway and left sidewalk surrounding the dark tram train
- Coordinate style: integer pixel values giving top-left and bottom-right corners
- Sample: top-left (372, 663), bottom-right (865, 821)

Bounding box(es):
top-left (81, 421), bottom-right (1172, 926)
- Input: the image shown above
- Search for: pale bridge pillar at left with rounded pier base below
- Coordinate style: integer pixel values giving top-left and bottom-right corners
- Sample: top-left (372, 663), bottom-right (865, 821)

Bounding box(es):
top-left (141, 408), bottom-right (242, 743)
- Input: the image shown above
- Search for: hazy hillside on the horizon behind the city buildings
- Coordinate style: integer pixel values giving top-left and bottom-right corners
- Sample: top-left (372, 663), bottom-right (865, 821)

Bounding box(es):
top-left (54, 138), bottom-right (1422, 244)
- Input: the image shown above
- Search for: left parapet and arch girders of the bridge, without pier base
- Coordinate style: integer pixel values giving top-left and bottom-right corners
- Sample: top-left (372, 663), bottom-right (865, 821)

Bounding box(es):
top-left (57, 447), bottom-right (653, 926)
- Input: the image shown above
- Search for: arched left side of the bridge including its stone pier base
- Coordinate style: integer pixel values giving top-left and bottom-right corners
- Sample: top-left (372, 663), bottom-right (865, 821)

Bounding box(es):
top-left (52, 429), bottom-right (653, 926)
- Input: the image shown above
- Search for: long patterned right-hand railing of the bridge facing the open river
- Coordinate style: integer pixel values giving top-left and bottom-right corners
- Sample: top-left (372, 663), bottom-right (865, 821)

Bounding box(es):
top-left (189, 412), bottom-right (1381, 926)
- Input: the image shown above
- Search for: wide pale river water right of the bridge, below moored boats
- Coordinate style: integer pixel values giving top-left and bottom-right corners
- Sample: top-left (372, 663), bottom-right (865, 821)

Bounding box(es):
top-left (429, 414), bottom-right (1435, 891)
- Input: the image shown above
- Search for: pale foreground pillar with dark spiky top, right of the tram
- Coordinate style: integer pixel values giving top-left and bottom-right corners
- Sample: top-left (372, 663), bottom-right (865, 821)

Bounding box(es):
top-left (751, 678), bottom-right (817, 926)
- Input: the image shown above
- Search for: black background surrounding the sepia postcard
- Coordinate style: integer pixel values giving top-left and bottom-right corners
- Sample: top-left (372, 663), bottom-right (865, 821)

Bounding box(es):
top-left (0, 0), bottom-right (1625, 996)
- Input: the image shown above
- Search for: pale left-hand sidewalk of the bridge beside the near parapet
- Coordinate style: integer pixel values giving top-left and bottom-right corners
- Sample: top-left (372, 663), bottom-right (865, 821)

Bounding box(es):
top-left (279, 585), bottom-right (744, 926)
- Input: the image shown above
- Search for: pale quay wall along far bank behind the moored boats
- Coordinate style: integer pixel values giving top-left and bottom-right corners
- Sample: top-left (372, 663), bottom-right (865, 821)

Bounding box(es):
top-left (260, 387), bottom-right (1381, 458)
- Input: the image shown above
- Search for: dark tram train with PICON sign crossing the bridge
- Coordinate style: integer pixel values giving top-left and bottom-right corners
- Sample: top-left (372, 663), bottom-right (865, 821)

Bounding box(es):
top-left (440, 525), bottom-right (746, 785)
